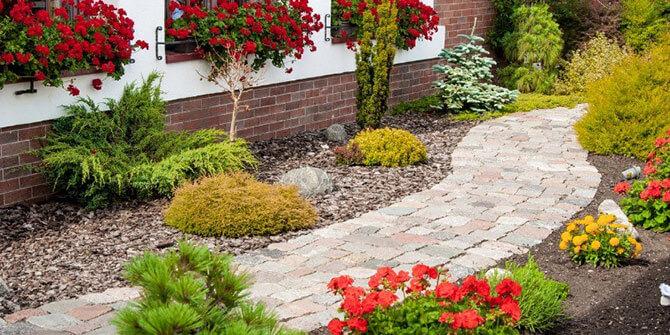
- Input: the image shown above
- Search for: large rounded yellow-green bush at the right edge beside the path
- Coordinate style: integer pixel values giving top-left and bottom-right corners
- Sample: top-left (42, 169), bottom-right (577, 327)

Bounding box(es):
top-left (575, 44), bottom-right (670, 159)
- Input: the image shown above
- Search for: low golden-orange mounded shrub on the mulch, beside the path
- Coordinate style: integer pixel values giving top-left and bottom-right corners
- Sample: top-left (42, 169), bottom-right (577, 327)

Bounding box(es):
top-left (165, 173), bottom-right (317, 237)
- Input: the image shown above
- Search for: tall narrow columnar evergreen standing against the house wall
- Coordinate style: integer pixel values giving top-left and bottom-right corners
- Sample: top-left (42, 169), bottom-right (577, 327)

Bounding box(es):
top-left (356, 0), bottom-right (398, 128)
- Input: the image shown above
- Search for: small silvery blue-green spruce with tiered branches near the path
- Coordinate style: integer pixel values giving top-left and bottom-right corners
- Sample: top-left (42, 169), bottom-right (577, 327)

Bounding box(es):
top-left (433, 35), bottom-right (518, 113)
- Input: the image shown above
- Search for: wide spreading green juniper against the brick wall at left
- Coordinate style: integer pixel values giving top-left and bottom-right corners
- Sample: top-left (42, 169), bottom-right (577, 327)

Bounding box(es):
top-left (36, 74), bottom-right (256, 208)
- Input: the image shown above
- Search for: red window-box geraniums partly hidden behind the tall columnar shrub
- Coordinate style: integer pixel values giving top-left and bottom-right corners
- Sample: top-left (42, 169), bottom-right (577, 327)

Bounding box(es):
top-left (331, 0), bottom-right (440, 50)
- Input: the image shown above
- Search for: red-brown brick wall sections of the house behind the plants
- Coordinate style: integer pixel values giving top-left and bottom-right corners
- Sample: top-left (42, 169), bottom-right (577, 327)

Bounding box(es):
top-left (0, 0), bottom-right (493, 206)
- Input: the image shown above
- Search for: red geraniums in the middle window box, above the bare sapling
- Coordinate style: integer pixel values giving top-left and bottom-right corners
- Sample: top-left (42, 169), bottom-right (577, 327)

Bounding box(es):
top-left (167, 0), bottom-right (323, 72)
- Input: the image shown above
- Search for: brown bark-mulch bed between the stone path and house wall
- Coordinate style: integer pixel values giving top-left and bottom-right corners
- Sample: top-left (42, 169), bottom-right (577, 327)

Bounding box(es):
top-left (0, 114), bottom-right (474, 314)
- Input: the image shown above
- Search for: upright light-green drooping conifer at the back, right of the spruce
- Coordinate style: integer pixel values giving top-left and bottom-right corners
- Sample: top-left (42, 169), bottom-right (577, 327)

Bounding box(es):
top-left (504, 4), bottom-right (563, 93)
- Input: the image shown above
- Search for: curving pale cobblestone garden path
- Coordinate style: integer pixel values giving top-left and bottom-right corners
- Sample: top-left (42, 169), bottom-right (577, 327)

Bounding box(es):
top-left (0, 106), bottom-right (600, 334)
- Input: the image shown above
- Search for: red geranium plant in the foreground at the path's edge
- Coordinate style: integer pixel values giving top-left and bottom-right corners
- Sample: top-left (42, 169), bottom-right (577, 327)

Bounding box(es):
top-left (328, 264), bottom-right (521, 335)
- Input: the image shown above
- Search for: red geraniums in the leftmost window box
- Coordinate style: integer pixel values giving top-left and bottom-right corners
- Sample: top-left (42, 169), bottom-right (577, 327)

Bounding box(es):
top-left (0, 0), bottom-right (148, 95)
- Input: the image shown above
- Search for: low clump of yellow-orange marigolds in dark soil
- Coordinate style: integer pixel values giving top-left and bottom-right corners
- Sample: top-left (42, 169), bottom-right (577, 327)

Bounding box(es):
top-left (559, 214), bottom-right (642, 268)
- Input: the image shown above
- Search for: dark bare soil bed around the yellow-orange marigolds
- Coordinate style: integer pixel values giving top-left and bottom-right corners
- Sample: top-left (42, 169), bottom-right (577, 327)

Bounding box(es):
top-left (512, 155), bottom-right (670, 335)
